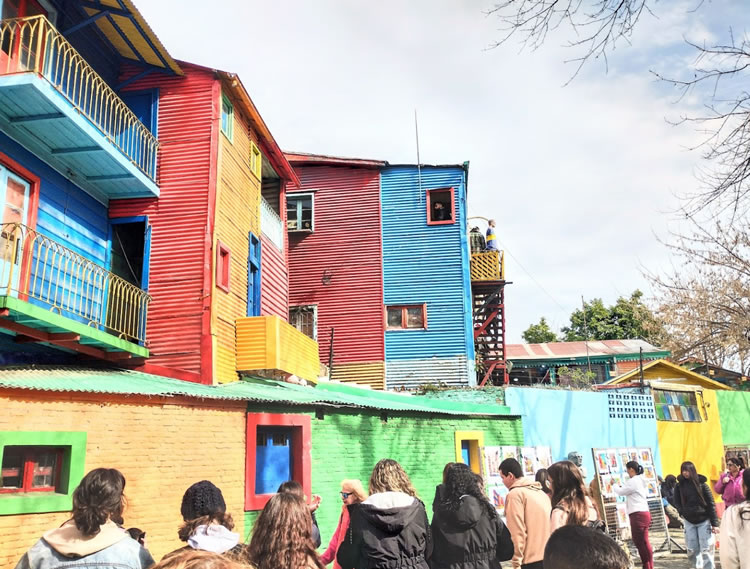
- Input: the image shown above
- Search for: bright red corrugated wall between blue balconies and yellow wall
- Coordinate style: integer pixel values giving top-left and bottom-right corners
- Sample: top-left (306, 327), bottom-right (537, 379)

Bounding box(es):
top-left (110, 64), bottom-right (219, 383)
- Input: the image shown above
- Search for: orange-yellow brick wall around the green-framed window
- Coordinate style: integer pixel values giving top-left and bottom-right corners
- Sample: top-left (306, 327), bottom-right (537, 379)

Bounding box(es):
top-left (0, 392), bottom-right (246, 569)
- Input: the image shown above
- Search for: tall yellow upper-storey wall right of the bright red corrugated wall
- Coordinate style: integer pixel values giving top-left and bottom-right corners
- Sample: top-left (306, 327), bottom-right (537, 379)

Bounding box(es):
top-left (212, 91), bottom-right (261, 383)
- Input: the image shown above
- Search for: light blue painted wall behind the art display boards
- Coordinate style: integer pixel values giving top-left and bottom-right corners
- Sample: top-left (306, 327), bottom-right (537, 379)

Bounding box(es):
top-left (505, 387), bottom-right (664, 481)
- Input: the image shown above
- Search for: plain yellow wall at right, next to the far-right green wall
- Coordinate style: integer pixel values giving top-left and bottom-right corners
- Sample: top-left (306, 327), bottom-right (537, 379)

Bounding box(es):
top-left (656, 389), bottom-right (724, 487)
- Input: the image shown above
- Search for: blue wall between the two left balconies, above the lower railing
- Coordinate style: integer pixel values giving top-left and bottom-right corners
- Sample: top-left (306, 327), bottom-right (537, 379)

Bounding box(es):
top-left (0, 133), bottom-right (109, 317)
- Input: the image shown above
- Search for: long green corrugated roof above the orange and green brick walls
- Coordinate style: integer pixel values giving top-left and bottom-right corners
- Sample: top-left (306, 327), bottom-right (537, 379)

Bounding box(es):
top-left (0, 366), bottom-right (510, 415)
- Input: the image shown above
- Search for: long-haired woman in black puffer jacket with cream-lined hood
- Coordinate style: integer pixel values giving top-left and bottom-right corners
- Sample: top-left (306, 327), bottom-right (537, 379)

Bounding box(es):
top-left (336, 458), bottom-right (432, 569)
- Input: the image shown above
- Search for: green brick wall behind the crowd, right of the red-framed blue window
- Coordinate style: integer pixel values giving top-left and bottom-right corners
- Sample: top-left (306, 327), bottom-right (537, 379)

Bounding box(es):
top-left (245, 411), bottom-right (523, 548)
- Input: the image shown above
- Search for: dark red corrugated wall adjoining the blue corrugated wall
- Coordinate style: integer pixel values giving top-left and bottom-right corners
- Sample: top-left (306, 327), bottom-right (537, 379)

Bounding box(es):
top-left (287, 166), bottom-right (385, 364)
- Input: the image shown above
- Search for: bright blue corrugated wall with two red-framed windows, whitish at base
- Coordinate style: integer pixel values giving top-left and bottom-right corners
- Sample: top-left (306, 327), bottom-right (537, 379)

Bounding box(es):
top-left (380, 166), bottom-right (474, 388)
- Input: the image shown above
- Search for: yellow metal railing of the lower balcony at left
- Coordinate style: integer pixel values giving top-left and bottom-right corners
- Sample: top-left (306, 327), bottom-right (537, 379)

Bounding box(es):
top-left (0, 223), bottom-right (151, 343)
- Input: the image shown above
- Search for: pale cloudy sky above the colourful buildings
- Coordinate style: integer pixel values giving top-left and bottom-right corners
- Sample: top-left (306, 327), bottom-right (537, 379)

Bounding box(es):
top-left (136, 0), bottom-right (747, 343)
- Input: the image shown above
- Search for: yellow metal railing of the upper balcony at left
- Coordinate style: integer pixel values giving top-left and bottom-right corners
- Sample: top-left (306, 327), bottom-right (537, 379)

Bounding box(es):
top-left (0, 16), bottom-right (159, 180)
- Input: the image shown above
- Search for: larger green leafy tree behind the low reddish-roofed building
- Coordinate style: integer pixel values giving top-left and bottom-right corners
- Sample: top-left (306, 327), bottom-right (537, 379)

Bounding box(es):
top-left (562, 290), bottom-right (665, 345)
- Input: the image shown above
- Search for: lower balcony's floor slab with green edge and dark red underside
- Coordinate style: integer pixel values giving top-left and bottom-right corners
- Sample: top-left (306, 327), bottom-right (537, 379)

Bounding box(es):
top-left (0, 296), bottom-right (149, 361)
